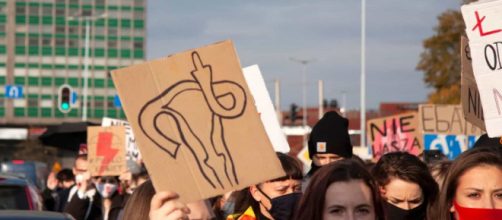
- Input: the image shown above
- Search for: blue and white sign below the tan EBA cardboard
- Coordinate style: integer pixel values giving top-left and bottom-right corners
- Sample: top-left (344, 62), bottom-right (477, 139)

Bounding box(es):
top-left (423, 134), bottom-right (477, 160)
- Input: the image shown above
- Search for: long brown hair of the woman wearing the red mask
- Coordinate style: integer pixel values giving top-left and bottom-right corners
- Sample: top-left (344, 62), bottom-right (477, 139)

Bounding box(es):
top-left (433, 147), bottom-right (502, 220)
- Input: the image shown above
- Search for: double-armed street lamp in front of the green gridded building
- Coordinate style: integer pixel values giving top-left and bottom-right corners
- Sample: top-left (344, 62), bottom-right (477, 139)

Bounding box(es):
top-left (68, 13), bottom-right (106, 122)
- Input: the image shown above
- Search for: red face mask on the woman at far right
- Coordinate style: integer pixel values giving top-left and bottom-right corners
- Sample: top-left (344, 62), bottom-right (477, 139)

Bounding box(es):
top-left (453, 201), bottom-right (502, 220)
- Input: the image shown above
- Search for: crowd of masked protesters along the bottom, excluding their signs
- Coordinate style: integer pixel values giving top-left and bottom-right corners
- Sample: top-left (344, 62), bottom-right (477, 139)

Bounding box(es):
top-left (39, 112), bottom-right (502, 220)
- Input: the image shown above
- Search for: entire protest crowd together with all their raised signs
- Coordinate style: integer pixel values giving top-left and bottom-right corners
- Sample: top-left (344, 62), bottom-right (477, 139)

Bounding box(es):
top-left (0, 0), bottom-right (502, 220)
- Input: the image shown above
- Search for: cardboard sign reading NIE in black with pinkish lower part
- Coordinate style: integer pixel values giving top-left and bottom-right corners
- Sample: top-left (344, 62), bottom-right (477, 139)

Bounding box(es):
top-left (366, 113), bottom-right (423, 160)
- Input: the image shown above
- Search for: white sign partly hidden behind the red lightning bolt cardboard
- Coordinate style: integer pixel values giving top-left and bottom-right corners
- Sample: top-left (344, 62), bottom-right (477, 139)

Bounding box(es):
top-left (101, 117), bottom-right (141, 162)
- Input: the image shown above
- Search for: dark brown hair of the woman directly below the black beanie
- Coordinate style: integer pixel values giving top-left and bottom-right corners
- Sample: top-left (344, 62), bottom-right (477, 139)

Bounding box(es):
top-left (294, 159), bottom-right (385, 220)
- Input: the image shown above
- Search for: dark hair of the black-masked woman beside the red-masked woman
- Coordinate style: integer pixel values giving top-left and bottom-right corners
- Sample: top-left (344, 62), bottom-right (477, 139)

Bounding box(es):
top-left (371, 152), bottom-right (439, 217)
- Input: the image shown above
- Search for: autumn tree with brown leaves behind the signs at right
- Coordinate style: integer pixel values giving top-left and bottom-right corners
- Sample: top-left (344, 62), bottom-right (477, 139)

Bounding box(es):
top-left (417, 0), bottom-right (472, 104)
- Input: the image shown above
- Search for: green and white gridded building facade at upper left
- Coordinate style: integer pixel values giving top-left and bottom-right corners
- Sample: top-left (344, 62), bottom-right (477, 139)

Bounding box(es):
top-left (0, 0), bottom-right (146, 122)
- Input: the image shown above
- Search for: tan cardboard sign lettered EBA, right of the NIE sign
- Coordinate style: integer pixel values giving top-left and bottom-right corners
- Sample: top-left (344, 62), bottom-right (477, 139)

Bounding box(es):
top-left (418, 104), bottom-right (483, 136)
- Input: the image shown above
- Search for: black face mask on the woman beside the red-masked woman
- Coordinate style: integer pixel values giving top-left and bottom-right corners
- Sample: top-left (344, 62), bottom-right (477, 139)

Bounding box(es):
top-left (383, 201), bottom-right (427, 220)
